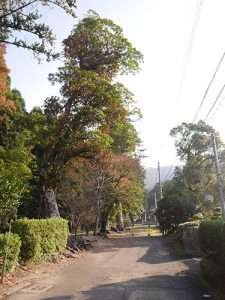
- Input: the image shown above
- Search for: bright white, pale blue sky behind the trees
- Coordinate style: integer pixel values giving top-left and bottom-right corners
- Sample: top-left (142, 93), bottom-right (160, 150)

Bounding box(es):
top-left (4, 0), bottom-right (225, 171)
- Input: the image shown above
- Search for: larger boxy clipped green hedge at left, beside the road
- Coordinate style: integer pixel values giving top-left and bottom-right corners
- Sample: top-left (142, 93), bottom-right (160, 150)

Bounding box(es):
top-left (12, 219), bottom-right (68, 261)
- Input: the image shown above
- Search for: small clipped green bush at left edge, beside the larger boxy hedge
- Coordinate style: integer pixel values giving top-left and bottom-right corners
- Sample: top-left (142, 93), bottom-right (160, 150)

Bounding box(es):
top-left (0, 233), bottom-right (21, 272)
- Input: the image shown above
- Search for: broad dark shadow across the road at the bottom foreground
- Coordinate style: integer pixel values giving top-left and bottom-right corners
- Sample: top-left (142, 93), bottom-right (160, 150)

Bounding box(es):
top-left (43, 273), bottom-right (204, 300)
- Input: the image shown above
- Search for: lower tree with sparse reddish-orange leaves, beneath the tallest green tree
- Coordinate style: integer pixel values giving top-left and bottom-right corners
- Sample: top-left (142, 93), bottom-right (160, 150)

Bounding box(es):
top-left (59, 150), bottom-right (143, 234)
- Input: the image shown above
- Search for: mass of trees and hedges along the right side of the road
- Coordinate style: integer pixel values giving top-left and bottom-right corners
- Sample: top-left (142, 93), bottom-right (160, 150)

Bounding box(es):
top-left (146, 121), bottom-right (225, 299)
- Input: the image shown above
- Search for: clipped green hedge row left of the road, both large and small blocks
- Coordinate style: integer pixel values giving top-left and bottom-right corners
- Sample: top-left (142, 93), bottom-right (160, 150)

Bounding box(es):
top-left (0, 219), bottom-right (68, 272)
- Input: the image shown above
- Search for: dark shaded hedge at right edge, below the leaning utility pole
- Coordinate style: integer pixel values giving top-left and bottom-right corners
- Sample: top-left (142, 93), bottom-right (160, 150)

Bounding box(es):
top-left (199, 220), bottom-right (223, 264)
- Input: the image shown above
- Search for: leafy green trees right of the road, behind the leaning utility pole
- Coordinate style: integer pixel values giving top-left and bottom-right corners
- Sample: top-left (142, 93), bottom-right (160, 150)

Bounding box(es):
top-left (156, 121), bottom-right (224, 233)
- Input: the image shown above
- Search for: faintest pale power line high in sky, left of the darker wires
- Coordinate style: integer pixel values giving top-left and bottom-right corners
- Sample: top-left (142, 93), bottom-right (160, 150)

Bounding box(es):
top-left (176, 0), bottom-right (203, 102)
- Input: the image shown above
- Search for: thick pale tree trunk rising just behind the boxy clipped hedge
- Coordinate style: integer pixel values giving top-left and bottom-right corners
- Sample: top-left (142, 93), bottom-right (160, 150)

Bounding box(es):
top-left (44, 187), bottom-right (60, 218)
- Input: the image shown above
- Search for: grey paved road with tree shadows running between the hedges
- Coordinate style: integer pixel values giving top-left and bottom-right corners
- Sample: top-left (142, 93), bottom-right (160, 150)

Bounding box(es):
top-left (6, 236), bottom-right (207, 300)
